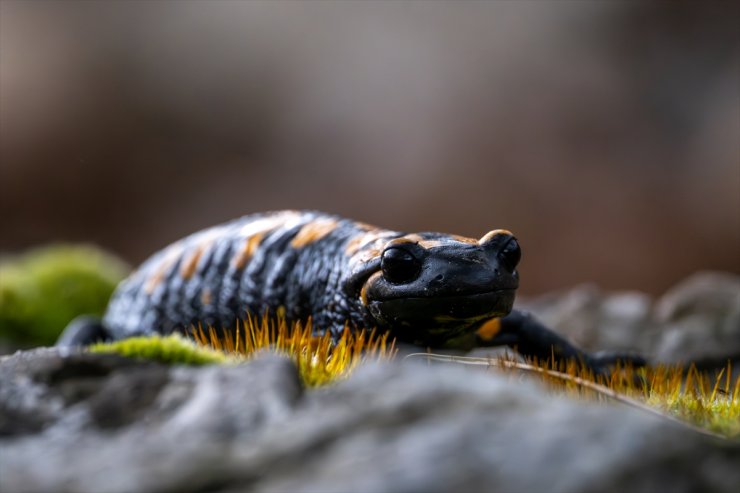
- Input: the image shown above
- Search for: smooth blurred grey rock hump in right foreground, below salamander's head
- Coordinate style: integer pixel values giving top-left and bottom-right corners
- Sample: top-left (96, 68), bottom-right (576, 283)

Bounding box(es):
top-left (242, 358), bottom-right (740, 492)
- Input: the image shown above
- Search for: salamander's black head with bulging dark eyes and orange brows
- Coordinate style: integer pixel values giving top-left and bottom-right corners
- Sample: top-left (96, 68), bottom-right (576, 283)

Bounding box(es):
top-left (360, 230), bottom-right (521, 345)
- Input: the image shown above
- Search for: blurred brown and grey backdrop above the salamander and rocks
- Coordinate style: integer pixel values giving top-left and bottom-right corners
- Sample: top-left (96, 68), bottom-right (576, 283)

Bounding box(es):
top-left (0, 0), bottom-right (740, 294)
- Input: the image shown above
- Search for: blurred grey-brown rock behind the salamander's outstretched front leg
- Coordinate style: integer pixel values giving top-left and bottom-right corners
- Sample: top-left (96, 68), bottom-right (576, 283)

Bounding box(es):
top-left (517, 272), bottom-right (740, 367)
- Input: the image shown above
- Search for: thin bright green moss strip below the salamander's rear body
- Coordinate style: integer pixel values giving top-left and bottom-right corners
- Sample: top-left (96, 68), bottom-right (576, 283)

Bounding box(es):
top-left (88, 335), bottom-right (228, 366)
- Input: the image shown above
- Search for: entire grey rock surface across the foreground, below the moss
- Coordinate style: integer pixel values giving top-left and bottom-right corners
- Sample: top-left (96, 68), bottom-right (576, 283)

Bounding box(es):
top-left (0, 349), bottom-right (740, 493)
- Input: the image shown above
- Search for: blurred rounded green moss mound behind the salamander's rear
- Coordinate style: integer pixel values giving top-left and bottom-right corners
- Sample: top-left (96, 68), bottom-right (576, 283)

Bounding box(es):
top-left (0, 245), bottom-right (128, 345)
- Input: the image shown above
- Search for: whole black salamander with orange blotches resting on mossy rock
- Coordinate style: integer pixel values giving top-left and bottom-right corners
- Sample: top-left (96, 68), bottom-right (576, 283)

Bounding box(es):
top-left (57, 211), bottom-right (641, 370)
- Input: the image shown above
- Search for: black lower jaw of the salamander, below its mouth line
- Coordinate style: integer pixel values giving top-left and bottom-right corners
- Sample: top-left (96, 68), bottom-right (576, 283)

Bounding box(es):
top-left (368, 289), bottom-right (516, 326)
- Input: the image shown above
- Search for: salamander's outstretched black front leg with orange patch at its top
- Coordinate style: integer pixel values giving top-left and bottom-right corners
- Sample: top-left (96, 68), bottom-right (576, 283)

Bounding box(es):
top-left (476, 310), bottom-right (646, 374)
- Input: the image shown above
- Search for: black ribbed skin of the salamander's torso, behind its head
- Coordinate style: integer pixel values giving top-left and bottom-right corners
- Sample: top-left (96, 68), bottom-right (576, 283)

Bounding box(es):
top-left (103, 211), bottom-right (376, 339)
